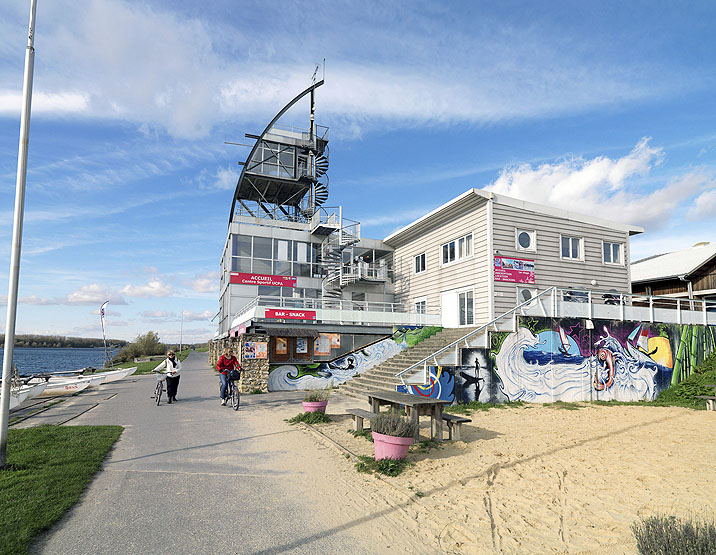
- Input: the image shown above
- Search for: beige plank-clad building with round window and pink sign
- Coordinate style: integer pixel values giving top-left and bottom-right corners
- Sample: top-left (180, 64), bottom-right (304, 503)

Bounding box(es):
top-left (384, 189), bottom-right (644, 327)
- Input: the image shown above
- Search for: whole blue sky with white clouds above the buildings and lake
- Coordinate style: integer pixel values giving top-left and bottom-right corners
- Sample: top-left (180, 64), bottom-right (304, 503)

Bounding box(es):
top-left (0, 0), bottom-right (716, 342)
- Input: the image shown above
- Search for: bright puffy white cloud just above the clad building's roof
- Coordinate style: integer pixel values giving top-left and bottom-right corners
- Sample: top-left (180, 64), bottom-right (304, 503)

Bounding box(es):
top-left (485, 138), bottom-right (713, 227)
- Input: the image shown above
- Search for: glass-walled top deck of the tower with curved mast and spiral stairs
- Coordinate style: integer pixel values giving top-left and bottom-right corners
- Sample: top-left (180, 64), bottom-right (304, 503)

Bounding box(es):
top-left (229, 80), bottom-right (328, 223)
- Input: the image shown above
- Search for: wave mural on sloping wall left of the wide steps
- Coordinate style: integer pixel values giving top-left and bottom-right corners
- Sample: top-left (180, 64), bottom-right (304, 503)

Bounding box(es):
top-left (268, 327), bottom-right (441, 391)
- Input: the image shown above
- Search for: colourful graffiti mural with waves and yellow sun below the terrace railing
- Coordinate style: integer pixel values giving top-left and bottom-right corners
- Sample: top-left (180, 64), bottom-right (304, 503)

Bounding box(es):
top-left (454, 318), bottom-right (716, 402)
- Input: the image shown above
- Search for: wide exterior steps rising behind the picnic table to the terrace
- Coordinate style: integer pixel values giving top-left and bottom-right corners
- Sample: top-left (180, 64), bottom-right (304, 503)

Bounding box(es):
top-left (337, 328), bottom-right (476, 402)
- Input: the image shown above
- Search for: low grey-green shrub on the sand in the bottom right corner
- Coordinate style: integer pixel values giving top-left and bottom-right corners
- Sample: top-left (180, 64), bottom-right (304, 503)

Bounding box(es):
top-left (631, 516), bottom-right (716, 555)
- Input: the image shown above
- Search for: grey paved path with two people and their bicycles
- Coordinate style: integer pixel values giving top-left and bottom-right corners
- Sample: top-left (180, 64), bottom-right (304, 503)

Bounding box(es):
top-left (32, 353), bottom-right (373, 554)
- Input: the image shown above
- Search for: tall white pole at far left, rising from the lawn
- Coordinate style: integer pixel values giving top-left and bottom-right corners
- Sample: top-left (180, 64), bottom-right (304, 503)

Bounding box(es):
top-left (0, 0), bottom-right (36, 468)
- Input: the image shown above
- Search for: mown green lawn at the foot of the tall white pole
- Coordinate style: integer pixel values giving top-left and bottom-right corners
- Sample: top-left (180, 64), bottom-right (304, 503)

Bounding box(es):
top-left (0, 426), bottom-right (123, 555)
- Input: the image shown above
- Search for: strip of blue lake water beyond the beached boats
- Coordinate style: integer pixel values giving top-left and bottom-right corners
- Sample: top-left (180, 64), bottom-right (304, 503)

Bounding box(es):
top-left (0, 347), bottom-right (118, 374)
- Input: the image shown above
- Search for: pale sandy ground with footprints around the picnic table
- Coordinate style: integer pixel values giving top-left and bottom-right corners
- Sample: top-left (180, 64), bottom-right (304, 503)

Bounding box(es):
top-left (282, 395), bottom-right (716, 553)
